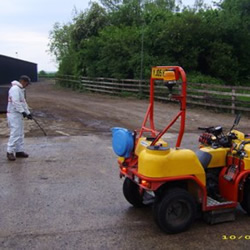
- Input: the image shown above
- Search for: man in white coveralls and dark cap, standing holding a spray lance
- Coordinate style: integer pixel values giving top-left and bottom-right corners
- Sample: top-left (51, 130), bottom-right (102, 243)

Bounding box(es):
top-left (7, 75), bottom-right (32, 161)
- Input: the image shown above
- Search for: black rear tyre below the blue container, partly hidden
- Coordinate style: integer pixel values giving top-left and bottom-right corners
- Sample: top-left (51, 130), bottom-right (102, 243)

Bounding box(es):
top-left (123, 178), bottom-right (144, 207)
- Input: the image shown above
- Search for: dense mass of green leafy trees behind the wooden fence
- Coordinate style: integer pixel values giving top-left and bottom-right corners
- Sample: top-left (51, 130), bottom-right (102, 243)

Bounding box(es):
top-left (50, 0), bottom-right (250, 84)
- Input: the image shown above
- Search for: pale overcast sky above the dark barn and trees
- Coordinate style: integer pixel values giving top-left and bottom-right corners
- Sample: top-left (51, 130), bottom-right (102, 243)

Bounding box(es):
top-left (0, 0), bottom-right (215, 71)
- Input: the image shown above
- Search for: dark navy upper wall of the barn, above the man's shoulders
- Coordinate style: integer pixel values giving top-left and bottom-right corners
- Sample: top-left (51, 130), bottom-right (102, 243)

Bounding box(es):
top-left (0, 55), bottom-right (38, 85)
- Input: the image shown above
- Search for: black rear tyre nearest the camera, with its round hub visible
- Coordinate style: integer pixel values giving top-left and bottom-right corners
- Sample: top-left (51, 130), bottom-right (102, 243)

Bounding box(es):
top-left (153, 188), bottom-right (196, 234)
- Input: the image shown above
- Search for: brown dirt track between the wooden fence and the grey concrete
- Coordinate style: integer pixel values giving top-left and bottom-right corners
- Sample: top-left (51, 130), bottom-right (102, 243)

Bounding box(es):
top-left (0, 79), bottom-right (250, 137)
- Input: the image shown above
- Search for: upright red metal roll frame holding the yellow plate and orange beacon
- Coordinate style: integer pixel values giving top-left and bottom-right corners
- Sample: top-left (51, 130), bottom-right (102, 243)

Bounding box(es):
top-left (139, 66), bottom-right (187, 147)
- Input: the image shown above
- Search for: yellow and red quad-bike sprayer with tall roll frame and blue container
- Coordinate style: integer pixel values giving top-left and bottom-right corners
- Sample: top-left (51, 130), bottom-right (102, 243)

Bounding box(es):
top-left (112, 66), bottom-right (250, 233)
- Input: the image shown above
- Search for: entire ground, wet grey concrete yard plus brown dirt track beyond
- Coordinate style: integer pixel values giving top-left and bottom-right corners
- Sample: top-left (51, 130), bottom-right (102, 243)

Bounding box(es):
top-left (0, 83), bottom-right (250, 249)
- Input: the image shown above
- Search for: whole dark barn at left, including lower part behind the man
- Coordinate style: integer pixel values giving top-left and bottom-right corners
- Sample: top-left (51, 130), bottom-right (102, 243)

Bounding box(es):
top-left (0, 55), bottom-right (37, 113)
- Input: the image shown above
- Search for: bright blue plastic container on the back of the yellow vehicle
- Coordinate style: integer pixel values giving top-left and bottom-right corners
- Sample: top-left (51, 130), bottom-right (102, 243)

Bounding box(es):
top-left (112, 127), bottom-right (134, 158)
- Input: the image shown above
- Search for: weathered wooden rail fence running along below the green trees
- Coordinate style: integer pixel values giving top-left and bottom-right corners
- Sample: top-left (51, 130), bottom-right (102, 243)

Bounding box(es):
top-left (55, 75), bottom-right (250, 114)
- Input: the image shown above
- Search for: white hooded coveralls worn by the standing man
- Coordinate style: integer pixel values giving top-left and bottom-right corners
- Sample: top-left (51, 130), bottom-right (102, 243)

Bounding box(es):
top-left (7, 81), bottom-right (30, 154)
